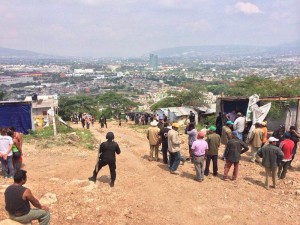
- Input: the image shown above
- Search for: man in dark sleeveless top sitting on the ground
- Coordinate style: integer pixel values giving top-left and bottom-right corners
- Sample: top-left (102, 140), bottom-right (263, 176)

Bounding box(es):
top-left (4, 170), bottom-right (50, 225)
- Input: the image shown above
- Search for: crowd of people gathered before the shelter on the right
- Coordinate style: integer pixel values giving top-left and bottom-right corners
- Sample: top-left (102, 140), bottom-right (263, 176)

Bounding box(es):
top-left (147, 112), bottom-right (300, 189)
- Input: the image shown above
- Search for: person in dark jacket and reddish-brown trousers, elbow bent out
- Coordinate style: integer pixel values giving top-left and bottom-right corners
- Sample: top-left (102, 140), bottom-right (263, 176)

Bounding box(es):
top-left (223, 131), bottom-right (249, 181)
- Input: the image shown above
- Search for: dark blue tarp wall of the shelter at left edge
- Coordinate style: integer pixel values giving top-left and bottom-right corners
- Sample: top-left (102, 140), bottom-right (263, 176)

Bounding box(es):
top-left (0, 102), bottom-right (32, 134)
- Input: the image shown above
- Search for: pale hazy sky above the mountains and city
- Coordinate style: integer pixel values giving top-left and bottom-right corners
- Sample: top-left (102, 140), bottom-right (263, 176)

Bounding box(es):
top-left (0, 0), bottom-right (300, 57)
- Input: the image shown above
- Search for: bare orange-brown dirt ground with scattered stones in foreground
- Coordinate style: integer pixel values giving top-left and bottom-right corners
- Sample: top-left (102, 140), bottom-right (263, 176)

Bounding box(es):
top-left (0, 122), bottom-right (300, 225)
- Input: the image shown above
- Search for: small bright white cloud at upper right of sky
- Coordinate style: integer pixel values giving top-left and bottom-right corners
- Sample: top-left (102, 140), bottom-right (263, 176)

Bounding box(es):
top-left (225, 2), bottom-right (262, 15)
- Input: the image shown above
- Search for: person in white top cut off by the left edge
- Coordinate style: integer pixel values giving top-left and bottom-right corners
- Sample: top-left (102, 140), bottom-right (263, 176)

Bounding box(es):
top-left (0, 128), bottom-right (14, 179)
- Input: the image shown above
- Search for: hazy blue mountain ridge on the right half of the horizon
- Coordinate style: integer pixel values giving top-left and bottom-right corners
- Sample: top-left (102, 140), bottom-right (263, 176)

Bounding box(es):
top-left (151, 42), bottom-right (300, 58)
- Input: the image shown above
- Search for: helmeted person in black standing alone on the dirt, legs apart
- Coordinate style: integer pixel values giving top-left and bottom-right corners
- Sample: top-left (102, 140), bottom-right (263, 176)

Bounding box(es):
top-left (89, 132), bottom-right (121, 187)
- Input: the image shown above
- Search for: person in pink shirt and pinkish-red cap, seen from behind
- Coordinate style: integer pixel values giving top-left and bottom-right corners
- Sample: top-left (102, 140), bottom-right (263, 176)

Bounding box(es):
top-left (191, 131), bottom-right (208, 182)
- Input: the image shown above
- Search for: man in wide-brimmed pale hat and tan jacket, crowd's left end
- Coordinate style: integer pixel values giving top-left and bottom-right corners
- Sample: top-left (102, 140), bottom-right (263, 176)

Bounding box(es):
top-left (147, 120), bottom-right (161, 161)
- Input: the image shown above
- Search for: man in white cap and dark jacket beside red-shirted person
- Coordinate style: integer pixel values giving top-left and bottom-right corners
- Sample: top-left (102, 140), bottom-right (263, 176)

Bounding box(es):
top-left (257, 137), bottom-right (283, 190)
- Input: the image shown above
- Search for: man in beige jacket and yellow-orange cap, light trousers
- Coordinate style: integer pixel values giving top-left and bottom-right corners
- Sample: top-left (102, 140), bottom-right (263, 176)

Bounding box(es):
top-left (168, 123), bottom-right (183, 174)
